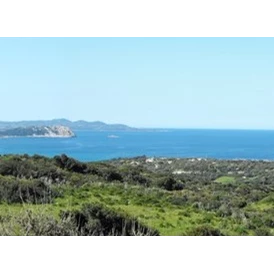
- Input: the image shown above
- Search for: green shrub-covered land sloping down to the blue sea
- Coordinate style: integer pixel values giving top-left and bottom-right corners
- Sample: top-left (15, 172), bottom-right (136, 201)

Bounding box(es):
top-left (0, 155), bottom-right (274, 236)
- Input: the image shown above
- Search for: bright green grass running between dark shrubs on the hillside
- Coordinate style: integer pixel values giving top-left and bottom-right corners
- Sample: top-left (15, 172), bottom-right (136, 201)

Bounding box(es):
top-left (0, 181), bottom-right (273, 236)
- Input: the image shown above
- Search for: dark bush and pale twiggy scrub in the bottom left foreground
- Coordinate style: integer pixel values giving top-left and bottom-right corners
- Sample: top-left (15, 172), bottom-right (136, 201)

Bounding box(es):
top-left (0, 204), bottom-right (158, 236)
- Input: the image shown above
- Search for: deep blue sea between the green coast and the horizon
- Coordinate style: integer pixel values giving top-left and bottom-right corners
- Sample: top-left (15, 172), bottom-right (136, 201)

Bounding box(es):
top-left (0, 129), bottom-right (274, 161)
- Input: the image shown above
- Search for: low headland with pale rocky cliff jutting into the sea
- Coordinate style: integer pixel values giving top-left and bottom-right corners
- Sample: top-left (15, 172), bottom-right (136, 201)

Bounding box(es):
top-left (0, 126), bottom-right (76, 138)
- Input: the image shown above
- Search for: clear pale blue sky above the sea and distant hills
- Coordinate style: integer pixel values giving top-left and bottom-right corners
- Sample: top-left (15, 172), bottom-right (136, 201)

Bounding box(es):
top-left (0, 37), bottom-right (274, 129)
